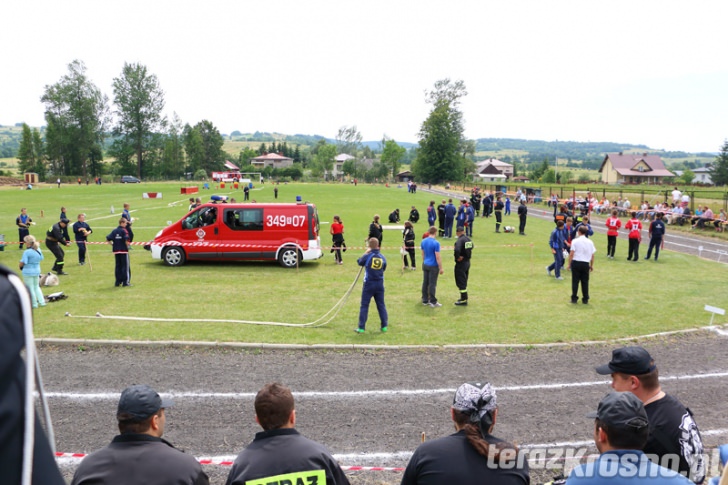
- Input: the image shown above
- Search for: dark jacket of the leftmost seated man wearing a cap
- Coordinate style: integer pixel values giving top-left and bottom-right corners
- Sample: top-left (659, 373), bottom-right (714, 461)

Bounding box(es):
top-left (71, 434), bottom-right (210, 485)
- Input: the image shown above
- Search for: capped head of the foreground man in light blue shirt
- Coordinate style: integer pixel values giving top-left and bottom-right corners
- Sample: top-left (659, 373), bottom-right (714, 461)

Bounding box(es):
top-left (587, 392), bottom-right (649, 450)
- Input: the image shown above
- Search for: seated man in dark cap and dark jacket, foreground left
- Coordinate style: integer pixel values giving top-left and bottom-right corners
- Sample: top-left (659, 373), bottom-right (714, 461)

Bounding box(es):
top-left (71, 385), bottom-right (209, 485)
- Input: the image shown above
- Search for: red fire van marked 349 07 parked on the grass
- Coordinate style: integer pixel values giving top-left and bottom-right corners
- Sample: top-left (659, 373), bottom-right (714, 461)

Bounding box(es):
top-left (144, 203), bottom-right (323, 268)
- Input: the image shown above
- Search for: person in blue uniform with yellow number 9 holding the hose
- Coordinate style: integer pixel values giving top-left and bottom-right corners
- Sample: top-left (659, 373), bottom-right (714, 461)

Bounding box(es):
top-left (356, 237), bottom-right (389, 333)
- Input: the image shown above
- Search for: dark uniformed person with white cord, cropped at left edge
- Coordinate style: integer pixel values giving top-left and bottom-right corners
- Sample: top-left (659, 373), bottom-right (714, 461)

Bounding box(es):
top-left (0, 266), bottom-right (66, 485)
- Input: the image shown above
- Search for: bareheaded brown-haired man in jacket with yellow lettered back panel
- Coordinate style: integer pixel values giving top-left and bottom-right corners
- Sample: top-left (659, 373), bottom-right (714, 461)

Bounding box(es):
top-left (225, 382), bottom-right (349, 485)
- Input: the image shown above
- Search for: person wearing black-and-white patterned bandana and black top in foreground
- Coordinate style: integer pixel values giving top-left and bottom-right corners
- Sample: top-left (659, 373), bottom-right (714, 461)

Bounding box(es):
top-left (401, 383), bottom-right (530, 485)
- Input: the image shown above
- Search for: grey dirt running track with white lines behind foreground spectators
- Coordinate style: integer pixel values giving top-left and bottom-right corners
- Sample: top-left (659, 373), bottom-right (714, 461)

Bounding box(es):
top-left (40, 329), bottom-right (728, 484)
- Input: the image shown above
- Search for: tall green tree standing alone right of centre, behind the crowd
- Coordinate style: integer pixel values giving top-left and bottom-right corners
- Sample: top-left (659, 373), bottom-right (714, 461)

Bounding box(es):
top-left (413, 79), bottom-right (468, 183)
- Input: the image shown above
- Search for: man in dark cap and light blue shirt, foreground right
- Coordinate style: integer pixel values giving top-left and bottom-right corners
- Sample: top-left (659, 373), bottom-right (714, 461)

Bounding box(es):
top-left (566, 392), bottom-right (691, 485)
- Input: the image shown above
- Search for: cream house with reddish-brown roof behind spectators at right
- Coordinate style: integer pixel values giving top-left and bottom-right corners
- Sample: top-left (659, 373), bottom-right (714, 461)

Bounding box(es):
top-left (599, 152), bottom-right (675, 184)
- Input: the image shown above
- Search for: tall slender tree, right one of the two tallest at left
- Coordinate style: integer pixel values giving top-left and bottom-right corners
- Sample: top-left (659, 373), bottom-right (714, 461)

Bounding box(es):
top-left (113, 63), bottom-right (166, 178)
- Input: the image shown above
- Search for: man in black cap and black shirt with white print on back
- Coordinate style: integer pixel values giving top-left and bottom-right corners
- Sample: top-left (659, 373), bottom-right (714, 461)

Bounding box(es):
top-left (596, 346), bottom-right (705, 484)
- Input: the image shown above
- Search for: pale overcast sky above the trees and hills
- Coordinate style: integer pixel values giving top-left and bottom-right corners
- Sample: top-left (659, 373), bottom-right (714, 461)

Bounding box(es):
top-left (0, 0), bottom-right (728, 152)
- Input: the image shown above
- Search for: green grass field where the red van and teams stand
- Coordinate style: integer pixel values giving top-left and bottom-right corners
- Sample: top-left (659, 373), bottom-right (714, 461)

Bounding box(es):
top-left (0, 183), bottom-right (728, 345)
